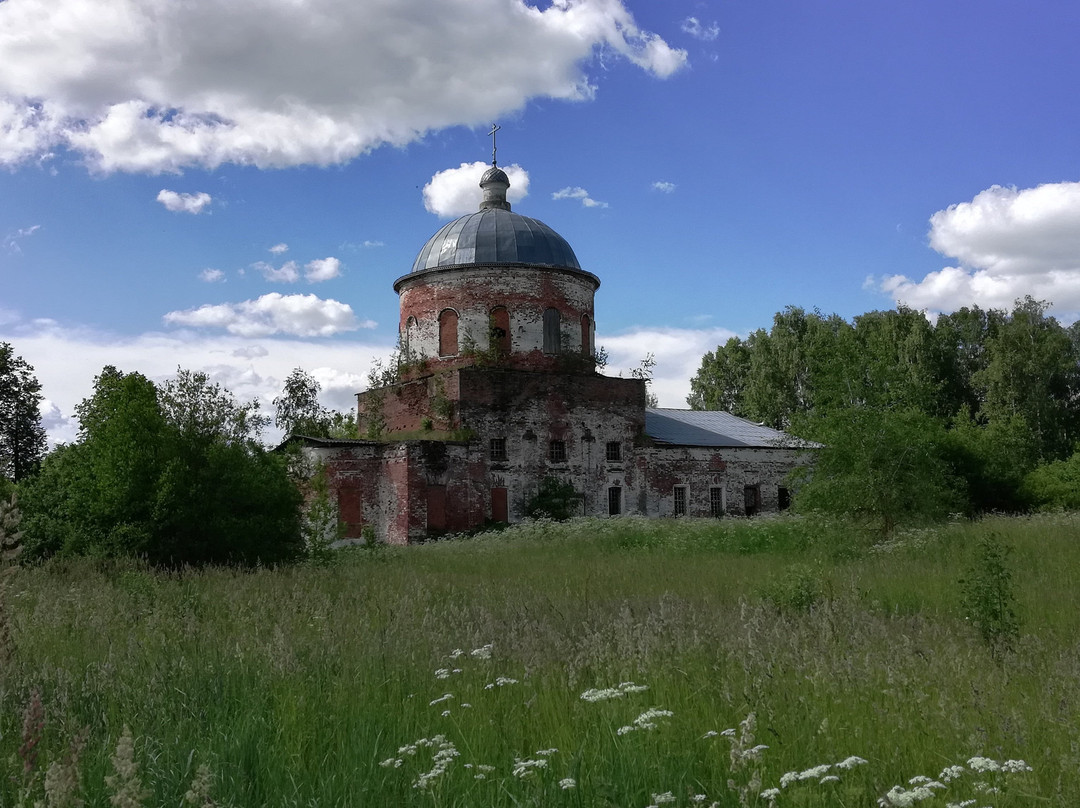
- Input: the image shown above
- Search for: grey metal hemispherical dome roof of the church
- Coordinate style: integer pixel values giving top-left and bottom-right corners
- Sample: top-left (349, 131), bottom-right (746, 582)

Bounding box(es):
top-left (413, 207), bottom-right (581, 272)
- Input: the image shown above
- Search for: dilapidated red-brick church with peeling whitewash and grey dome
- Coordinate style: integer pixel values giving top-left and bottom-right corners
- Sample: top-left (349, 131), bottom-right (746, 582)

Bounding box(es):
top-left (295, 153), bottom-right (808, 544)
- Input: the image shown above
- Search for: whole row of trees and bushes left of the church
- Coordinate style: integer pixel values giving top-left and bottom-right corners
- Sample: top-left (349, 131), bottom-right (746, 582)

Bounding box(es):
top-left (0, 344), bottom-right (355, 566)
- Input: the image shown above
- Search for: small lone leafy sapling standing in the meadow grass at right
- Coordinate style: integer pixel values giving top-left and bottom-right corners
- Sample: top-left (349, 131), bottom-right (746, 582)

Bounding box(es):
top-left (960, 533), bottom-right (1020, 652)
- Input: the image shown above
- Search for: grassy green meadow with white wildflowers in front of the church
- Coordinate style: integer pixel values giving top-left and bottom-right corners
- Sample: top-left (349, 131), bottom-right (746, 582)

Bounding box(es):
top-left (0, 514), bottom-right (1080, 808)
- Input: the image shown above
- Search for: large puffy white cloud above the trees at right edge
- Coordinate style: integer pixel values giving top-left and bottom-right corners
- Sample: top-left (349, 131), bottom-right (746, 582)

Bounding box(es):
top-left (880, 183), bottom-right (1080, 312)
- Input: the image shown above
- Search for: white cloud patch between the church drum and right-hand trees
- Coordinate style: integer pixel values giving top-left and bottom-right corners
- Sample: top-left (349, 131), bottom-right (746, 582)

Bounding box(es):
top-left (596, 327), bottom-right (735, 408)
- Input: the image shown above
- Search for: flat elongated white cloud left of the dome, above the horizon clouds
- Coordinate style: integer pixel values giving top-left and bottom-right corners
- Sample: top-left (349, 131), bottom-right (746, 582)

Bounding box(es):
top-left (164, 292), bottom-right (375, 337)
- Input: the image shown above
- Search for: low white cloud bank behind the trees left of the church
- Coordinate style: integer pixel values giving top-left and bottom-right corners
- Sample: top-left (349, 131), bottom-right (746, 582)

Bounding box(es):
top-left (0, 324), bottom-right (393, 444)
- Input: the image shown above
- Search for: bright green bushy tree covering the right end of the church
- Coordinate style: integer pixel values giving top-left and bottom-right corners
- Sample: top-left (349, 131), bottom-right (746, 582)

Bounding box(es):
top-left (792, 407), bottom-right (963, 535)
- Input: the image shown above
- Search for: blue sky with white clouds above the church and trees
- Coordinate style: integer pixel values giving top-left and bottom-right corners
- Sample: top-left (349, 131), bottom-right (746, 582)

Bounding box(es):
top-left (0, 0), bottom-right (1080, 443)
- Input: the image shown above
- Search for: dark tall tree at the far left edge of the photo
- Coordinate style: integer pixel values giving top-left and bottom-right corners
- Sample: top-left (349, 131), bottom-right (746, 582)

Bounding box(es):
top-left (0, 342), bottom-right (46, 482)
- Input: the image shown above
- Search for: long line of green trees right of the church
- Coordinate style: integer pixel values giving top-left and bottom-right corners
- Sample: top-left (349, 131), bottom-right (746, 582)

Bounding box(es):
top-left (688, 297), bottom-right (1080, 529)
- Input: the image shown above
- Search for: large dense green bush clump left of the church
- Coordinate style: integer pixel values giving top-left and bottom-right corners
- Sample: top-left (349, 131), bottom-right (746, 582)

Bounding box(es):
top-left (24, 367), bottom-right (300, 565)
